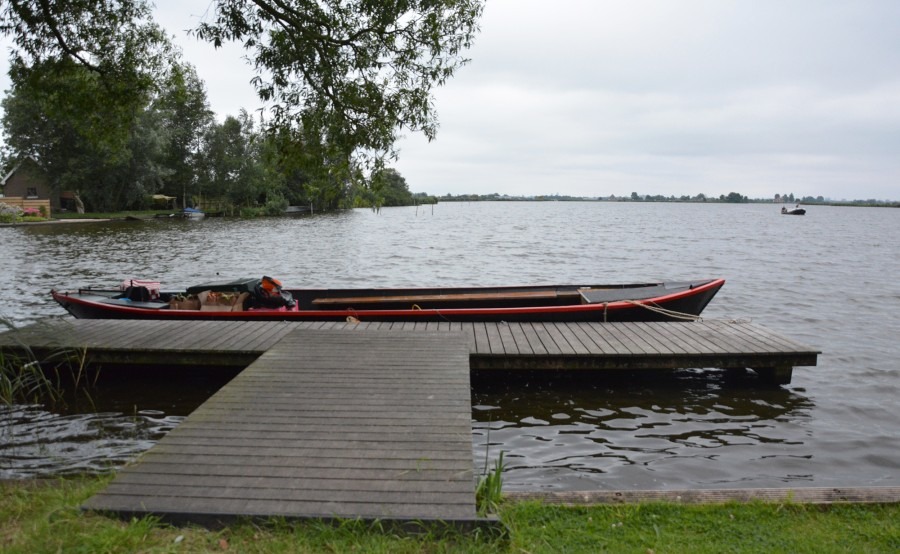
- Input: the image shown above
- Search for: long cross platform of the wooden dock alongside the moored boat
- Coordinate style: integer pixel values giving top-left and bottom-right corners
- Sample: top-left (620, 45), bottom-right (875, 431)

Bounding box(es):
top-left (0, 320), bottom-right (819, 384)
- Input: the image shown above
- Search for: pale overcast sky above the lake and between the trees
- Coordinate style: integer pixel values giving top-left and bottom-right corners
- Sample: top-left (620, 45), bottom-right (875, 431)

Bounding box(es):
top-left (3, 0), bottom-right (900, 199)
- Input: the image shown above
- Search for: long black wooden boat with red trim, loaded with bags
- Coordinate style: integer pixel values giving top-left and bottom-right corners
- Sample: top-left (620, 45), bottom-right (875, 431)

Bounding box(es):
top-left (51, 278), bottom-right (725, 321)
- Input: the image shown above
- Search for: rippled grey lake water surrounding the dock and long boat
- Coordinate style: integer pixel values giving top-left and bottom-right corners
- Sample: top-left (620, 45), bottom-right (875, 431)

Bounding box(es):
top-left (0, 202), bottom-right (900, 490)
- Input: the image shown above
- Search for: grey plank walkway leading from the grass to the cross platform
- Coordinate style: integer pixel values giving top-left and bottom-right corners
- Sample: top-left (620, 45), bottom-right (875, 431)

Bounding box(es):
top-left (85, 329), bottom-right (483, 526)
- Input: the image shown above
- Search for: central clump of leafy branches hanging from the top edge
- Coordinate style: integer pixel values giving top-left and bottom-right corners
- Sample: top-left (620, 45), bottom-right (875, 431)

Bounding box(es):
top-left (195, 0), bottom-right (483, 157)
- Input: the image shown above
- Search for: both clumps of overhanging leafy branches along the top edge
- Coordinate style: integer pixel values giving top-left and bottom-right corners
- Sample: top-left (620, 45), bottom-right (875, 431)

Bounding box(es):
top-left (0, 0), bottom-right (484, 185)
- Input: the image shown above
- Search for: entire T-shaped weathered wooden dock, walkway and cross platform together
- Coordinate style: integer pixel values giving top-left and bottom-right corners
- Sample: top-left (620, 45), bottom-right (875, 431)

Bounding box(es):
top-left (0, 320), bottom-right (818, 529)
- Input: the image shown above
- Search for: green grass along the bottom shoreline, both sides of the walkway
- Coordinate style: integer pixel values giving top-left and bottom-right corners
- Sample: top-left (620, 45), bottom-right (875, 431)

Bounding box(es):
top-left (0, 477), bottom-right (900, 554)
